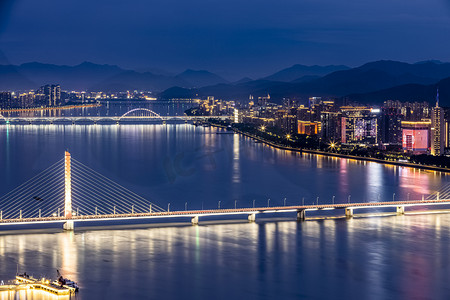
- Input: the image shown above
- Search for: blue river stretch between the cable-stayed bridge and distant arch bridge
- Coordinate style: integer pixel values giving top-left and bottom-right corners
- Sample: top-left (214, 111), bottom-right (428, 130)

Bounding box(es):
top-left (0, 124), bottom-right (448, 210)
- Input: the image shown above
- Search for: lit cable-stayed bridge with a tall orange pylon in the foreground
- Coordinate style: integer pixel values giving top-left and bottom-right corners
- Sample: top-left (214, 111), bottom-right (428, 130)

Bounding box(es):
top-left (0, 151), bottom-right (450, 230)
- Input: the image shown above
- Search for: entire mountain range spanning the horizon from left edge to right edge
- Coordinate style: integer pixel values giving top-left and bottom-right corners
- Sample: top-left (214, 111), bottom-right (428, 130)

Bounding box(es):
top-left (0, 60), bottom-right (450, 105)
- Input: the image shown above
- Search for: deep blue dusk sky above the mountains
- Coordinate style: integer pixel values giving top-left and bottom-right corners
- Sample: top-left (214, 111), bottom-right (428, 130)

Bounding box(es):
top-left (0, 0), bottom-right (450, 78)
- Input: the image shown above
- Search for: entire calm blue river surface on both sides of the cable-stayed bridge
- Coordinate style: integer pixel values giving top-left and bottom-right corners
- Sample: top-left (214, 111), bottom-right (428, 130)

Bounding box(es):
top-left (0, 116), bottom-right (450, 299)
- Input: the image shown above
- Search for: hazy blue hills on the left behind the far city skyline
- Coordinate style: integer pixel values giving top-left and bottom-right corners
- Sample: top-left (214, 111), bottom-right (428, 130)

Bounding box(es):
top-left (0, 62), bottom-right (227, 91)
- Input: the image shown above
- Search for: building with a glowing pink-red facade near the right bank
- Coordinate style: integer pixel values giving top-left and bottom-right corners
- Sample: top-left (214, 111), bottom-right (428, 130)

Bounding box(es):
top-left (402, 121), bottom-right (431, 154)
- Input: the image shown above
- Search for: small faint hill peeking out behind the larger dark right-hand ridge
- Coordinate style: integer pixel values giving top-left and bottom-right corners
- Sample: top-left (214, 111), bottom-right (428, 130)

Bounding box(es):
top-left (262, 64), bottom-right (350, 82)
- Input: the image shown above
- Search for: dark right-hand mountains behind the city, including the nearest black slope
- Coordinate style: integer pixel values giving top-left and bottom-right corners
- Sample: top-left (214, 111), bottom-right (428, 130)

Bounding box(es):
top-left (160, 60), bottom-right (450, 105)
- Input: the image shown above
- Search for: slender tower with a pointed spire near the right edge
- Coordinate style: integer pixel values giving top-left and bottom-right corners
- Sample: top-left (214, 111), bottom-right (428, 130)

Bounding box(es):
top-left (431, 89), bottom-right (445, 155)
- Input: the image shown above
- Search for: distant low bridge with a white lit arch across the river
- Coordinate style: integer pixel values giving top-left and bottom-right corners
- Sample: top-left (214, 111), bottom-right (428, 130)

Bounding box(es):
top-left (0, 108), bottom-right (232, 124)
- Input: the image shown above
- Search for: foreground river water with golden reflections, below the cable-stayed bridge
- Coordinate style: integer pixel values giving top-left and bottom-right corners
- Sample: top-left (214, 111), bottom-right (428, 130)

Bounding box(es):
top-left (0, 214), bottom-right (450, 299)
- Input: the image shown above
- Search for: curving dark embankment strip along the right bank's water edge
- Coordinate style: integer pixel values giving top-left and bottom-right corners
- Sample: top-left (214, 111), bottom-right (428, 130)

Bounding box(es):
top-left (211, 124), bottom-right (450, 173)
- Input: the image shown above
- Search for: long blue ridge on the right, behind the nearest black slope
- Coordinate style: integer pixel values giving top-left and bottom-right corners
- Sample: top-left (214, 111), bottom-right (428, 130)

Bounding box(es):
top-left (161, 61), bottom-right (450, 102)
